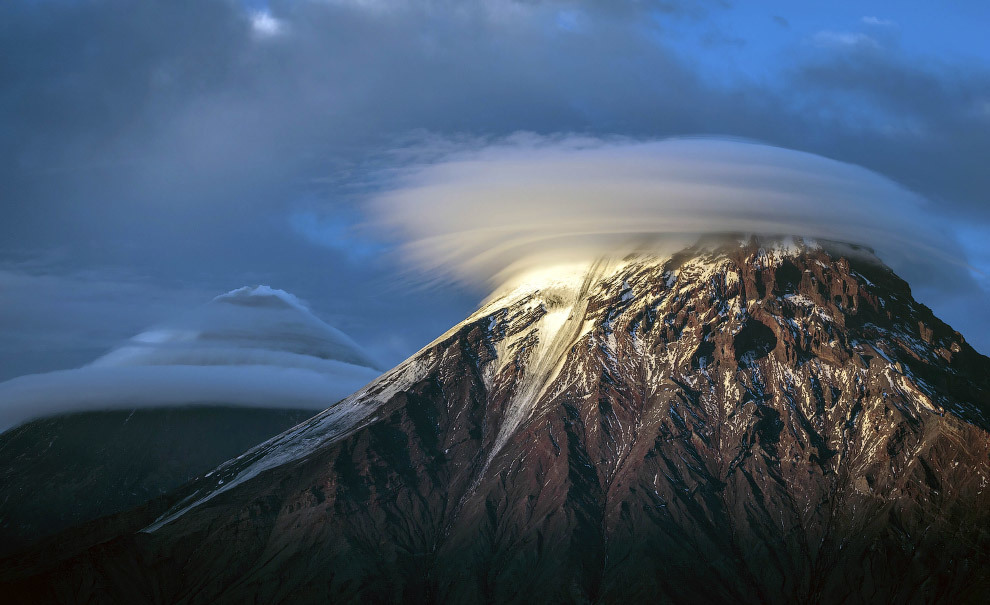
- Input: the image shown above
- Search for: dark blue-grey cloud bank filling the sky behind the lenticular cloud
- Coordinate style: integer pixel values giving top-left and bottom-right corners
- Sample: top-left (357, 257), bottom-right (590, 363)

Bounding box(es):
top-left (0, 0), bottom-right (990, 382)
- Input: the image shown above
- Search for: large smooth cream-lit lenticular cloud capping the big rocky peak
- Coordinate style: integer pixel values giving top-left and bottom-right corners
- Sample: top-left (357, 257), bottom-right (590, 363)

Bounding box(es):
top-left (371, 135), bottom-right (951, 285)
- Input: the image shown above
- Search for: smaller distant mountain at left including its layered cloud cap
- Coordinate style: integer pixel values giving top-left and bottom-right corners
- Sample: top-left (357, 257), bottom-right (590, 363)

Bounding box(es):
top-left (0, 286), bottom-right (380, 553)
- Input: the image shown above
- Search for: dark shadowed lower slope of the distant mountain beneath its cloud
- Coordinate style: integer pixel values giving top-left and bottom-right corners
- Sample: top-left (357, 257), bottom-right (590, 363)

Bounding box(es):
top-left (0, 406), bottom-right (313, 555)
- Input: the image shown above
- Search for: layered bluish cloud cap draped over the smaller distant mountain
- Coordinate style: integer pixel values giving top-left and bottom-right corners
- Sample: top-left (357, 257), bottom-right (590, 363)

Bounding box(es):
top-left (0, 286), bottom-right (380, 430)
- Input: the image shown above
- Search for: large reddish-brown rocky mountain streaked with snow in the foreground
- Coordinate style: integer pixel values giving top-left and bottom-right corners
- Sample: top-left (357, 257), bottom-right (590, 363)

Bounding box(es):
top-left (0, 240), bottom-right (990, 603)
